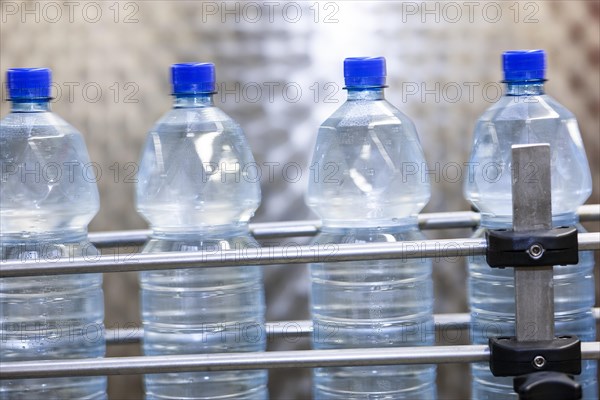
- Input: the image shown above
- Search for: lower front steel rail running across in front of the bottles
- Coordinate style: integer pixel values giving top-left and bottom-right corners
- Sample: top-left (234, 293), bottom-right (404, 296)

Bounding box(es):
top-left (0, 342), bottom-right (600, 379)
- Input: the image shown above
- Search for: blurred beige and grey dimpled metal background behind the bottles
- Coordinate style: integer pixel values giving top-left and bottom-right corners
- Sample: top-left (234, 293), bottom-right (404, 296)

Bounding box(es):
top-left (0, 0), bottom-right (600, 399)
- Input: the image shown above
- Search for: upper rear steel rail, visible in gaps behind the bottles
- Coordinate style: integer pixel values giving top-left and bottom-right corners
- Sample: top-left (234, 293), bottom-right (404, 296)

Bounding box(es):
top-left (89, 204), bottom-right (600, 248)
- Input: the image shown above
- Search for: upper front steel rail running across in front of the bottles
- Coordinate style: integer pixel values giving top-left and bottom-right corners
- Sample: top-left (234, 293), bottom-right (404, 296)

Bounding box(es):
top-left (0, 232), bottom-right (600, 278)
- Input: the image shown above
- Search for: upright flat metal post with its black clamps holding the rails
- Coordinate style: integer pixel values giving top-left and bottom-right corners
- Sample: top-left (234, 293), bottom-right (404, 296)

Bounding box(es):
top-left (487, 143), bottom-right (581, 400)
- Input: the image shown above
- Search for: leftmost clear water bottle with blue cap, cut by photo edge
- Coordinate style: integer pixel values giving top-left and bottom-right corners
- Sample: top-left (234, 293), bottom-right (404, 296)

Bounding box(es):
top-left (0, 68), bottom-right (106, 399)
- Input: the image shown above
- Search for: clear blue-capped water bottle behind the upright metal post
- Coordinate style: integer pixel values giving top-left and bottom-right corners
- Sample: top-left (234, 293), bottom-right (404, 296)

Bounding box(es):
top-left (465, 50), bottom-right (598, 400)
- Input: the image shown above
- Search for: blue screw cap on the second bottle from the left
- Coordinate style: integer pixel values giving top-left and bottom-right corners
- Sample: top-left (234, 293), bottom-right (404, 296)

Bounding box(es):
top-left (171, 63), bottom-right (215, 94)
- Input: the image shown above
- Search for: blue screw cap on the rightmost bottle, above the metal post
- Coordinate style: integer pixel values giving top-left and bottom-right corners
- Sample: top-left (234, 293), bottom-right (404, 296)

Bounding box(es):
top-left (502, 50), bottom-right (546, 82)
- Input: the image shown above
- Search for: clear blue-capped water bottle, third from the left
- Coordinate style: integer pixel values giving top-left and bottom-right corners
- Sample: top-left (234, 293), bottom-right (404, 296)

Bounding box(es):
top-left (307, 57), bottom-right (436, 399)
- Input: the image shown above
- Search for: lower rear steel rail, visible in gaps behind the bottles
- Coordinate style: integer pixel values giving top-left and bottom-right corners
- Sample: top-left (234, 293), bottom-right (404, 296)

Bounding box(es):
top-left (104, 308), bottom-right (600, 344)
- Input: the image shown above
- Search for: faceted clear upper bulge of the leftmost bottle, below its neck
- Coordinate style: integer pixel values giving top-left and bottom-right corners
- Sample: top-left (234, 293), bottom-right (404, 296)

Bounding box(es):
top-left (0, 112), bottom-right (99, 233)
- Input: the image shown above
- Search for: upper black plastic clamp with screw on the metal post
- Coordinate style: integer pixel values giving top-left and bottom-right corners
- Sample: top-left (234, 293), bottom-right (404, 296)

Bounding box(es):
top-left (486, 227), bottom-right (579, 268)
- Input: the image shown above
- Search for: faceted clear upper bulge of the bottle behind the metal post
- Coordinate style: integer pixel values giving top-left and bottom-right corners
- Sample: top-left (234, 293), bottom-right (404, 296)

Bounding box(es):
top-left (463, 95), bottom-right (592, 221)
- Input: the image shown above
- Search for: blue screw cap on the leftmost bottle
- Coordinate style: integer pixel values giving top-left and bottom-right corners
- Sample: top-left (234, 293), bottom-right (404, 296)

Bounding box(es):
top-left (6, 68), bottom-right (52, 100)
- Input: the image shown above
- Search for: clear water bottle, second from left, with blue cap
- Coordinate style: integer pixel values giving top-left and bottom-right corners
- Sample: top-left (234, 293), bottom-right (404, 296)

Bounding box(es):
top-left (137, 63), bottom-right (267, 399)
